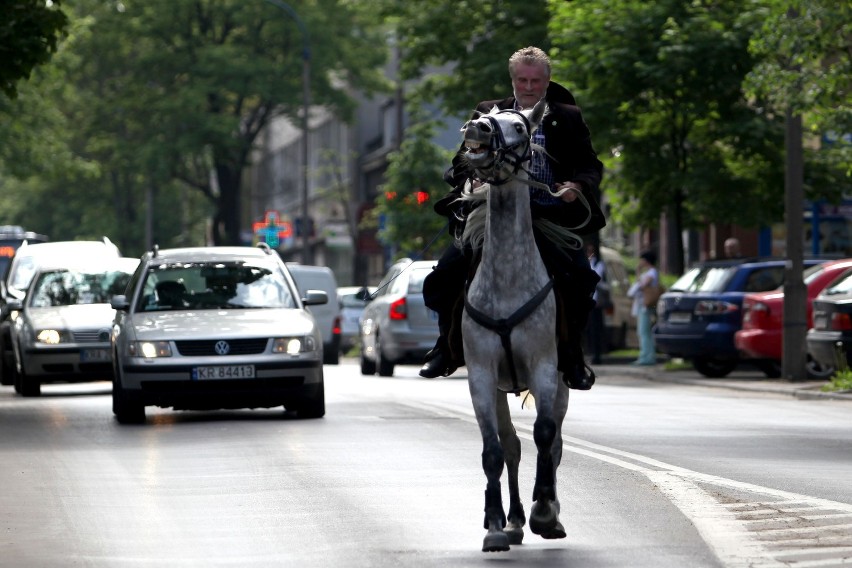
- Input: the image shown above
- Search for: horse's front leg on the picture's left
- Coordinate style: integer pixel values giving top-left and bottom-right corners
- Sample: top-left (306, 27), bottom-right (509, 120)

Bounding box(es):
top-left (468, 369), bottom-right (509, 552)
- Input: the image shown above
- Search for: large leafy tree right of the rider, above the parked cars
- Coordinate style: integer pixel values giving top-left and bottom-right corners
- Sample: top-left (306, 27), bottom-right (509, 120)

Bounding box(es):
top-left (550, 0), bottom-right (783, 272)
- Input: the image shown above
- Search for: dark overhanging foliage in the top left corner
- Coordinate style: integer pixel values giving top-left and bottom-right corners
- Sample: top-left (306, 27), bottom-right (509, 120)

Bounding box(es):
top-left (0, 0), bottom-right (68, 99)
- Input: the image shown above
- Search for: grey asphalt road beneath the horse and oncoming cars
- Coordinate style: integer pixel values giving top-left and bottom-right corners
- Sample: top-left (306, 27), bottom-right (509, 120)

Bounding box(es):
top-left (0, 360), bottom-right (852, 568)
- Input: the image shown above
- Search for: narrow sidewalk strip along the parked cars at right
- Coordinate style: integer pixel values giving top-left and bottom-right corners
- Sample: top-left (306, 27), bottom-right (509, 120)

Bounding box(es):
top-left (594, 358), bottom-right (852, 401)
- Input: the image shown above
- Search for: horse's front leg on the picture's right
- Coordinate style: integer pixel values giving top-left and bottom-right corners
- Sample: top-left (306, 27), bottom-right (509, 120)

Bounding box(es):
top-left (530, 365), bottom-right (567, 538)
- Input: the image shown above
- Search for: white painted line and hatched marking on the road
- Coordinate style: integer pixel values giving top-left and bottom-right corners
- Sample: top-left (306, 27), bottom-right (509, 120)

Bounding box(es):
top-left (412, 402), bottom-right (852, 568)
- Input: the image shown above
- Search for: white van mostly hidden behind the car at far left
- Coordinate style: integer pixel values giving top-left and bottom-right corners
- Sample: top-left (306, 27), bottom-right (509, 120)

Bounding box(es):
top-left (0, 237), bottom-right (121, 385)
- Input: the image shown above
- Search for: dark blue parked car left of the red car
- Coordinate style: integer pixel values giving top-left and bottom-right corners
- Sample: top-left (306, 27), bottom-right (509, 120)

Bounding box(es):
top-left (654, 258), bottom-right (825, 378)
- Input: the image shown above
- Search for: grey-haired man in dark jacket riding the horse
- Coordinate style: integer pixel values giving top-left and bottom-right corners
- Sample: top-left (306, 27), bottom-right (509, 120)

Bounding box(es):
top-left (420, 47), bottom-right (606, 390)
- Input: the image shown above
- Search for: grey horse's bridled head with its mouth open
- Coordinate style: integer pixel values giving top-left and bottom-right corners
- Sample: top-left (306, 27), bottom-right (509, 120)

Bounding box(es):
top-left (461, 99), bottom-right (547, 182)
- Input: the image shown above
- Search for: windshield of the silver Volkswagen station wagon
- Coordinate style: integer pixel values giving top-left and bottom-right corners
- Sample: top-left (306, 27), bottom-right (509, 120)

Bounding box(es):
top-left (137, 261), bottom-right (296, 311)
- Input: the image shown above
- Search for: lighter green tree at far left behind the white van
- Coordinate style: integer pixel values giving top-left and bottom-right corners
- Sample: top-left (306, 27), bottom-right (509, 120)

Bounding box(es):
top-left (0, 13), bottom-right (208, 256)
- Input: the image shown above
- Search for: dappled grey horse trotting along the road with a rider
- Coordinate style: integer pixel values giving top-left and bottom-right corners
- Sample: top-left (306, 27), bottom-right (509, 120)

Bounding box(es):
top-left (462, 101), bottom-right (568, 552)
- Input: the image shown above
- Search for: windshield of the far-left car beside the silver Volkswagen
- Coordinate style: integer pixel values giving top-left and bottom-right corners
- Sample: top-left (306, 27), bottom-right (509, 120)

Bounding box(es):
top-left (29, 270), bottom-right (130, 308)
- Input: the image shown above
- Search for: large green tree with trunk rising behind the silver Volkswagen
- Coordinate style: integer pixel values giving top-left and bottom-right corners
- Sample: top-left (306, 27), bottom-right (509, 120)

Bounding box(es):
top-left (65, 0), bottom-right (392, 244)
